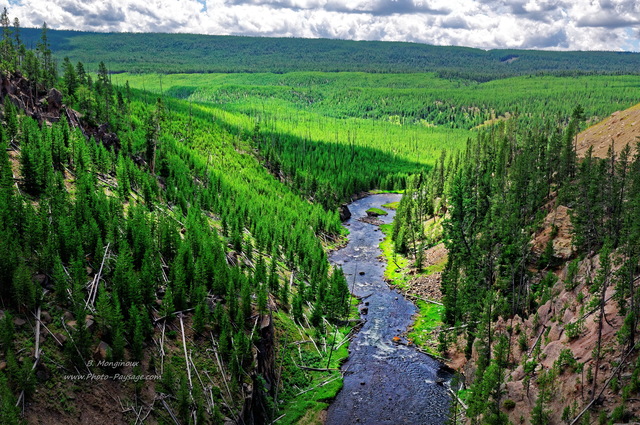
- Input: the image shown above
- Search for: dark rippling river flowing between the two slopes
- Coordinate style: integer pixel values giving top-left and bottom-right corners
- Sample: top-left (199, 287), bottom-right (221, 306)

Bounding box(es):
top-left (326, 194), bottom-right (451, 425)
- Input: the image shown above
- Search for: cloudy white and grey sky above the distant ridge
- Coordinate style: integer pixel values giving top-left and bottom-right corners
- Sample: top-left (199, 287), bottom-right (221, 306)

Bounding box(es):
top-left (0, 0), bottom-right (640, 52)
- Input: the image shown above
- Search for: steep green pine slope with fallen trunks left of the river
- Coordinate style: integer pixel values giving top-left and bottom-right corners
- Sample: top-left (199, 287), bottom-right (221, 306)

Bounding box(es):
top-left (0, 16), bottom-right (358, 424)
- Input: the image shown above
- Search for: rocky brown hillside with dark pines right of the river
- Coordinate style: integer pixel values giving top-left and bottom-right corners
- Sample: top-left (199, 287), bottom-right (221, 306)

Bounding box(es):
top-left (393, 107), bottom-right (640, 424)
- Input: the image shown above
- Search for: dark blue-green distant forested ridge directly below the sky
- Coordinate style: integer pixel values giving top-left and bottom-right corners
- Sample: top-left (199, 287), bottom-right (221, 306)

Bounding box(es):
top-left (13, 29), bottom-right (640, 81)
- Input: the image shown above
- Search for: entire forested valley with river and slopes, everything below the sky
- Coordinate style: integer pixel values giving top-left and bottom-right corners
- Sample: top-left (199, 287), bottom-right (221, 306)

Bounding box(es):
top-left (0, 21), bottom-right (640, 425)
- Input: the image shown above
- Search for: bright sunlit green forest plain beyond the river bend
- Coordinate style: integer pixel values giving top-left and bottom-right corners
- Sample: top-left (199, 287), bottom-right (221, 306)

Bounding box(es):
top-left (119, 72), bottom-right (640, 208)
